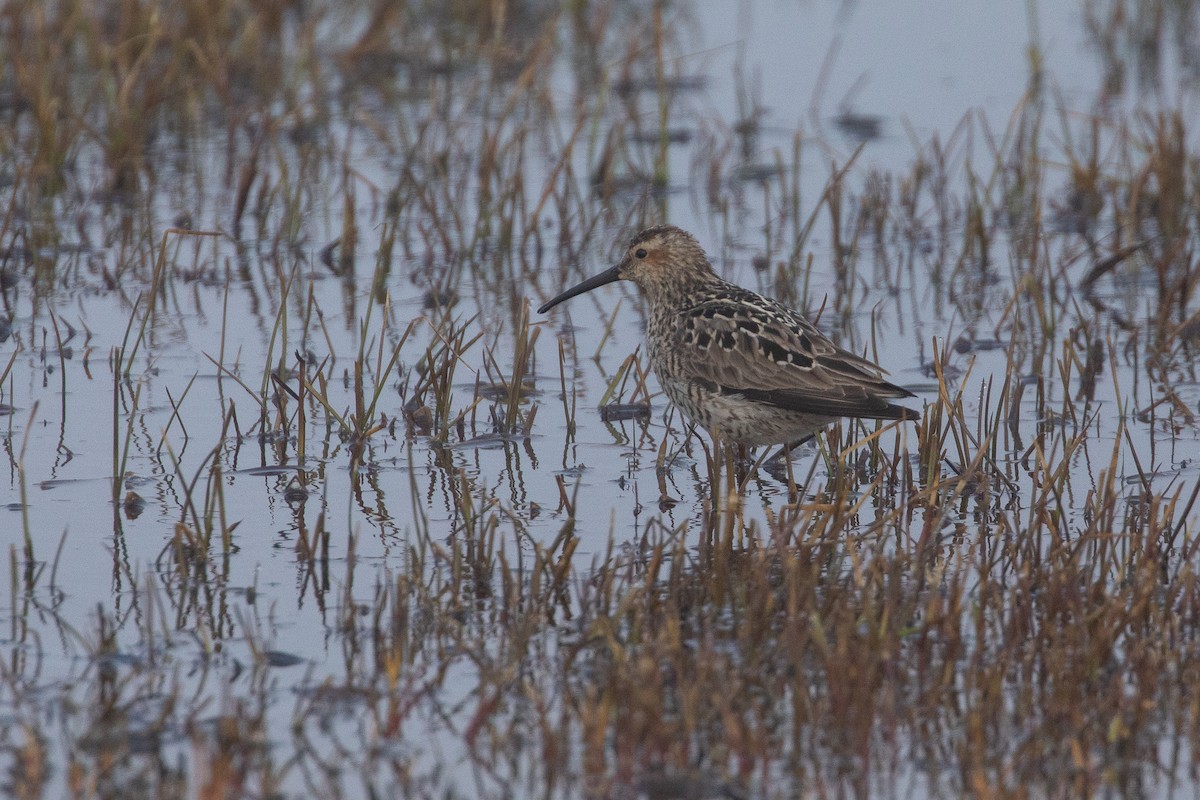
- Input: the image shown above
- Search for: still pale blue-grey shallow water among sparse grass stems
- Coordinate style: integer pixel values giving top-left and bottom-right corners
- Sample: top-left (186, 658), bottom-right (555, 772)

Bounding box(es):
top-left (0, 0), bottom-right (1200, 796)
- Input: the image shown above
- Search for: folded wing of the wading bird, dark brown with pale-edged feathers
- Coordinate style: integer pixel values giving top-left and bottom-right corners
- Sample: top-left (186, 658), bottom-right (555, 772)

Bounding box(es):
top-left (674, 291), bottom-right (916, 420)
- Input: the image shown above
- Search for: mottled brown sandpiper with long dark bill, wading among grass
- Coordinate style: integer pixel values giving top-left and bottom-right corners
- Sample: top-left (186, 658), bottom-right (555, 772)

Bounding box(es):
top-left (538, 225), bottom-right (917, 446)
